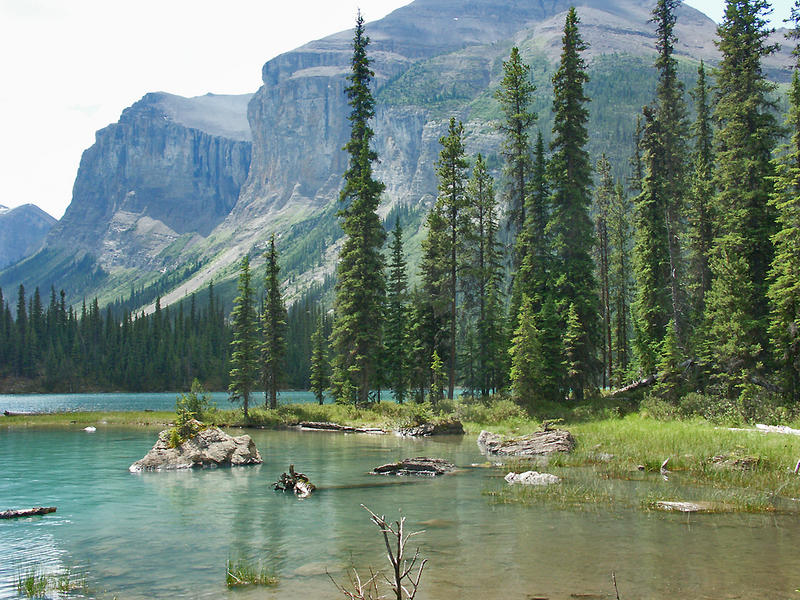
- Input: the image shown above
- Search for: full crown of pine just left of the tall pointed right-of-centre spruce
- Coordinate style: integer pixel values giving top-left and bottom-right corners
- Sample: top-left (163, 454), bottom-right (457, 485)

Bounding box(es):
top-left (495, 46), bottom-right (536, 239)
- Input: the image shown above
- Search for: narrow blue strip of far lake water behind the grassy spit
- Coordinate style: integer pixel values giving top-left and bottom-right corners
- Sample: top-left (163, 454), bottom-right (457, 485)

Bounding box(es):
top-left (0, 391), bottom-right (324, 416)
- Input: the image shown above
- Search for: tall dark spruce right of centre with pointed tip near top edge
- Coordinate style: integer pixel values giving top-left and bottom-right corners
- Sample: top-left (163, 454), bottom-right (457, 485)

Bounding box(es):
top-left (548, 7), bottom-right (600, 401)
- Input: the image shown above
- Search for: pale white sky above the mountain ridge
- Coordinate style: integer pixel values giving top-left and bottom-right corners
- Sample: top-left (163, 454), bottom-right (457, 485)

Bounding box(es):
top-left (0, 0), bottom-right (791, 218)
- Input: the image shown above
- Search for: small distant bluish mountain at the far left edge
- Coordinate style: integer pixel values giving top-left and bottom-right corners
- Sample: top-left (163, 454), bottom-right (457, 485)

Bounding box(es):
top-left (0, 204), bottom-right (56, 269)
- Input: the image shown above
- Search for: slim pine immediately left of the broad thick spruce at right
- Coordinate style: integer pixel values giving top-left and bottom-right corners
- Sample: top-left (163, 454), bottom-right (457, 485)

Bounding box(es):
top-left (687, 61), bottom-right (714, 337)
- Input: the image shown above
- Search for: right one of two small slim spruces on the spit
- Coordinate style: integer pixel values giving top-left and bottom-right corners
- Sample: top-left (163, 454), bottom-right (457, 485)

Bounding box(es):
top-left (260, 234), bottom-right (288, 410)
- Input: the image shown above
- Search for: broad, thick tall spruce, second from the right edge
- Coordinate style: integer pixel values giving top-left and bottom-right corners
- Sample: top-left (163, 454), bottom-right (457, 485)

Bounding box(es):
top-left (705, 0), bottom-right (777, 397)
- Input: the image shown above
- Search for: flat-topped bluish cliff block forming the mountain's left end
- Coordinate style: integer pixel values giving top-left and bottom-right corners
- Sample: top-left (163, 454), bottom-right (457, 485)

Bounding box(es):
top-left (47, 93), bottom-right (251, 270)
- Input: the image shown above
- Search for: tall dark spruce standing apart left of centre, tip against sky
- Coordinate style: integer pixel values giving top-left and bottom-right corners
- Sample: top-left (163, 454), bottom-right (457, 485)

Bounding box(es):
top-left (331, 12), bottom-right (386, 404)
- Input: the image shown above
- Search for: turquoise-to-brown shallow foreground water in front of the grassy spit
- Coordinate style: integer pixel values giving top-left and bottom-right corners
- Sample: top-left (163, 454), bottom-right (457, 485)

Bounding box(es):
top-left (0, 421), bottom-right (800, 600)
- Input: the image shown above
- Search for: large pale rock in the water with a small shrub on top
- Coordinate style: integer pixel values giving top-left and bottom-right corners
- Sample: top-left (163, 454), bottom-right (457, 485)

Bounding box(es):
top-left (129, 427), bottom-right (261, 473)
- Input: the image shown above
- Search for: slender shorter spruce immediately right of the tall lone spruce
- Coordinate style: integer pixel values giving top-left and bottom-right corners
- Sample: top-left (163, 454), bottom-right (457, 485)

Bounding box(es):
top-left (384, 219), bottom-right (409, 404)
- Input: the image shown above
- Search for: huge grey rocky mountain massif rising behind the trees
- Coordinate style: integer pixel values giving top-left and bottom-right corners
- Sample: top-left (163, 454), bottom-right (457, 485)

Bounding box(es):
top-left (0, 0), bottom-right (792, 308)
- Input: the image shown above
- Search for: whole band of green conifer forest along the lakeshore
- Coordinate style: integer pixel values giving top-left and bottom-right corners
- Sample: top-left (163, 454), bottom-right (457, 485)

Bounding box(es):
top-left (0, 0), bottom-right (800, 414)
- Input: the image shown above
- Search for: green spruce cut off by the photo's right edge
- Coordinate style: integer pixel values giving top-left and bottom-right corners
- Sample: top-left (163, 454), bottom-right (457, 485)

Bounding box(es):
top-left (768, 0), bottom-right (800, 402)
